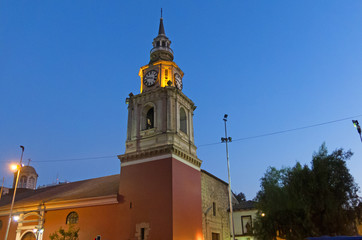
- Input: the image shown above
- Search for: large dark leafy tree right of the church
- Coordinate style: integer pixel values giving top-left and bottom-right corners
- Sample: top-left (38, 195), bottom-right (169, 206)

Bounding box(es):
top-left (255, 144), bottom-right (360, 240)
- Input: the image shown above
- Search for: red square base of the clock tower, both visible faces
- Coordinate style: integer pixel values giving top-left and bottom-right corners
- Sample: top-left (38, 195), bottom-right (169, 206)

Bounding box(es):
top-left (119, 157), bottom-right (202, 240)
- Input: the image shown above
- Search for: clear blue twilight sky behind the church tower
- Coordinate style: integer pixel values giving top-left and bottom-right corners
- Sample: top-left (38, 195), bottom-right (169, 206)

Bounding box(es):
top-left (0, 0), bottom-right (362, 199)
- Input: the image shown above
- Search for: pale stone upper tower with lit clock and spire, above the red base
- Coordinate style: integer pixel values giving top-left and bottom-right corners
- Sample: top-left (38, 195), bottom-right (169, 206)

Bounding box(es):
top-left (124, 17), bottom-right (201, 167)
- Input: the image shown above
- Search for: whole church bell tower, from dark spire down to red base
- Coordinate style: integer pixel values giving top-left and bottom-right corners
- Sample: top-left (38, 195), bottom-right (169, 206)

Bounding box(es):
top-left (118, 14), bottom-right (203, 240)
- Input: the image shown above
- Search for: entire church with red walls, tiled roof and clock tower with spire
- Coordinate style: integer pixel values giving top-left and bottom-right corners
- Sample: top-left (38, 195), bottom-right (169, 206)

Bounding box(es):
top-left (0, 17), bottom-right (230, 240)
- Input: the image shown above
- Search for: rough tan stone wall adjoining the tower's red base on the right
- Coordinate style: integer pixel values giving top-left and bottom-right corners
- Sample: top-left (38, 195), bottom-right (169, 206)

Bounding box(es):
top-left (201, 171), bottom-right (230, 240)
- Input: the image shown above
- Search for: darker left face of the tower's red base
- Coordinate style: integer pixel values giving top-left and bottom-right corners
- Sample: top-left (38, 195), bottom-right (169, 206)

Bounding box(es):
top-left (118, 158), bottom-right (172, 240)
